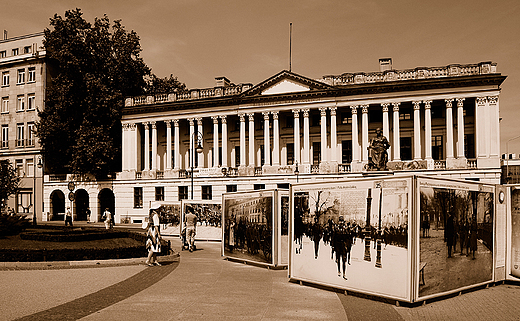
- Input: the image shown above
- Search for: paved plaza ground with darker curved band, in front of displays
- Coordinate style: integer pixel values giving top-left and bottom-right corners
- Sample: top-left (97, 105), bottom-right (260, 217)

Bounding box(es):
top-left (0, 224), bottom-right (520, 321)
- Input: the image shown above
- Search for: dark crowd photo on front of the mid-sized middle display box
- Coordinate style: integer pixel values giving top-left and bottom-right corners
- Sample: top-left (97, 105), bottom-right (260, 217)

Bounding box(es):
top-left (224, 192), bottom-right (273, 264)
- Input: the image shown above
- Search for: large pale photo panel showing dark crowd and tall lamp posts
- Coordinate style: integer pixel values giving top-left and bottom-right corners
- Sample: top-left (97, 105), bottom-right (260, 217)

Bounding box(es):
top-left (289, 177), bottom-right (412, 300)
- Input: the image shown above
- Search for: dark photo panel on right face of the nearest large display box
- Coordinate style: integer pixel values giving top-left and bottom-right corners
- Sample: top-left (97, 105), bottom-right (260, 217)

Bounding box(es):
top-left (417, 178), bottom-right (495, 298)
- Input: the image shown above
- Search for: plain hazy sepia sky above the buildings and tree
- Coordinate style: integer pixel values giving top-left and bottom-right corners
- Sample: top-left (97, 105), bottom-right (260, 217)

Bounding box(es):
top-left (4, 0), bottom-right (520, 155)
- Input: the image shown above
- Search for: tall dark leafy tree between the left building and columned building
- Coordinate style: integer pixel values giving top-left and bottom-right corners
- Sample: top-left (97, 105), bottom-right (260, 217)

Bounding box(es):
top-left (36, 9), bottom-right (184, 178)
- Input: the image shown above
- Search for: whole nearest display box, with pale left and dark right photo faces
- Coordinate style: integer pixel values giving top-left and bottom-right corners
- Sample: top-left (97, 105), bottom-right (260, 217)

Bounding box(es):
top-left (289, 175), bottom-right (498, 303)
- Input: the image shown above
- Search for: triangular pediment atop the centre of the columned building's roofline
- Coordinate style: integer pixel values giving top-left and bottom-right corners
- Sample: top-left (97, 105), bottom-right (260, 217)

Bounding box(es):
top-left (244, 70), bottom-right (331, 96)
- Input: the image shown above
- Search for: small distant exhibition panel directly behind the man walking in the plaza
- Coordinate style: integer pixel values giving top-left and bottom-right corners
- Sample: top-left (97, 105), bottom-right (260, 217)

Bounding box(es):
top-left (181, 200), bottom-right (222, 241)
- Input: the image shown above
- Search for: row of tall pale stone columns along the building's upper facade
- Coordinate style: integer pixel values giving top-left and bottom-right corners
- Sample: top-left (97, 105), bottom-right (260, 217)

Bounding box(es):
top-left (123, 96), bottom-right (499, 170)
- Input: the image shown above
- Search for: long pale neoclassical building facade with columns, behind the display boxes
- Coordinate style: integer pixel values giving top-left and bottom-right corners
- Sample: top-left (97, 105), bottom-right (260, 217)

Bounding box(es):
top-left (43, 59), bottom-right (506, 222)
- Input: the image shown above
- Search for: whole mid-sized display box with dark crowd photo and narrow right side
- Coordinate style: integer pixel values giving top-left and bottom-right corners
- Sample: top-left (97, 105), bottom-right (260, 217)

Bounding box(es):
top-left (222, 190), bottom-right (289, 267)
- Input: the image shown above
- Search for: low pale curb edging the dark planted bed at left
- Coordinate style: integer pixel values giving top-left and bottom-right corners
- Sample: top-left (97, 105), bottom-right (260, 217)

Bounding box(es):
top-left (0, 253), bottom-right (180, 270)
